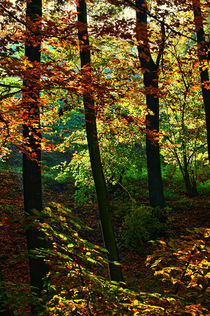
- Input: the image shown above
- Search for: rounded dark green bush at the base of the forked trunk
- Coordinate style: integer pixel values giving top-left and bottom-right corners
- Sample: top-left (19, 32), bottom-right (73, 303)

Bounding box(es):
top-left (122, 206), bottom-right (167, 249)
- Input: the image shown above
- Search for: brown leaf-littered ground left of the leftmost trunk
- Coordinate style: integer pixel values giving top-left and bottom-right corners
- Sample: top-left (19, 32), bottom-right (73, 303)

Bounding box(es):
top-left (0, 171), bottom-right (30, 315)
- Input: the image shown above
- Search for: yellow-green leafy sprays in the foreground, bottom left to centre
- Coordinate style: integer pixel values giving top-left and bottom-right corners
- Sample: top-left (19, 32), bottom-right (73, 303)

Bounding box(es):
top-left (37, 204), bottom-right (167, 315)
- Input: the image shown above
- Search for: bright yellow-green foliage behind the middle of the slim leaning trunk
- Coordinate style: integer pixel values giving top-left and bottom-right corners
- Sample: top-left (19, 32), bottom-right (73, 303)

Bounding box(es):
top-left (54, 122), bottom-right (145, 205)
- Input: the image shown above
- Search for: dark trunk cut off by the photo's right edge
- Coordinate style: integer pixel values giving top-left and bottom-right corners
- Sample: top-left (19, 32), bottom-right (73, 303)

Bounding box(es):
top-left (192, 0), bottom-right (210, 161)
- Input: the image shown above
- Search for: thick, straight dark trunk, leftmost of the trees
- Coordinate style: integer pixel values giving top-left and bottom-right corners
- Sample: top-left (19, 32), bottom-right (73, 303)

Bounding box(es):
top-left (23, 0), bottom-right (46, 290)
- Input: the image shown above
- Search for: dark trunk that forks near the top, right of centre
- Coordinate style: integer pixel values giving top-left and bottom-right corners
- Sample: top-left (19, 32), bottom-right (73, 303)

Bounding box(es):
top-left (136, 0), bottom-right (165, 208)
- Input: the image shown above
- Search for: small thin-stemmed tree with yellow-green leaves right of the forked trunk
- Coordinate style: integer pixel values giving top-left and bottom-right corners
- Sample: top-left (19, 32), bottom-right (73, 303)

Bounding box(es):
top-left (160, 39), bottom-right (205, 197)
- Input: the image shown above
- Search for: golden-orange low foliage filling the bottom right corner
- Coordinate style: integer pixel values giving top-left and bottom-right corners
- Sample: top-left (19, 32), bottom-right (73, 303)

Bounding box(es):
top-left (147, 228), bottom-right (210, 315)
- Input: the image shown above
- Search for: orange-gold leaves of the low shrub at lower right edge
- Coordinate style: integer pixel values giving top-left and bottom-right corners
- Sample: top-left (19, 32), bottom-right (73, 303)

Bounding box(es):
top-left (147, 228), bottom-right (209, 311)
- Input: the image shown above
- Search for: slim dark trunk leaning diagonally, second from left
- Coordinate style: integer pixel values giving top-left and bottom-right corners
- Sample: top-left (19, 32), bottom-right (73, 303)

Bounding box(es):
top-left (77, 0), bottom-right (122, 281)
